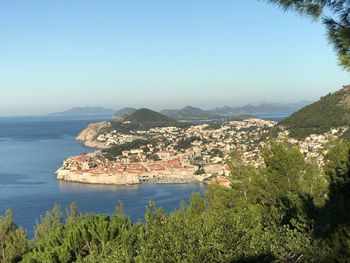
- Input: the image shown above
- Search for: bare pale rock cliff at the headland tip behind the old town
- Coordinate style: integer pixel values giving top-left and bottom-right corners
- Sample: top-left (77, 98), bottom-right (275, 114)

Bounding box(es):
top-left (76, 121), bottom-right (111, 149)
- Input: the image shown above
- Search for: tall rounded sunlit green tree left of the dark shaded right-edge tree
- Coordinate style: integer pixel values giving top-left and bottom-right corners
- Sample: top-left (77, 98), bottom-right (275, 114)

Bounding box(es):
top-left (261, 141), bottom-right (328, 224)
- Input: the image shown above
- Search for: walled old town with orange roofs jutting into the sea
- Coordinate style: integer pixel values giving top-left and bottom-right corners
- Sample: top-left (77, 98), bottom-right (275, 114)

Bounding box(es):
top-left (56, 153), bottom-right (201, 184)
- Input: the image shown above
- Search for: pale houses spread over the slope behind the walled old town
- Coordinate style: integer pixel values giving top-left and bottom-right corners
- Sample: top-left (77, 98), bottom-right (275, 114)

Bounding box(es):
top-left (98, 119), bottom-right (276, 168)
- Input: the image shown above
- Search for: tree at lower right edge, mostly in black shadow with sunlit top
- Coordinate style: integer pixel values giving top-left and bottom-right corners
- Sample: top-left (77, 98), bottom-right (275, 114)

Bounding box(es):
top-left (315, 140), bottom-right (350, 262)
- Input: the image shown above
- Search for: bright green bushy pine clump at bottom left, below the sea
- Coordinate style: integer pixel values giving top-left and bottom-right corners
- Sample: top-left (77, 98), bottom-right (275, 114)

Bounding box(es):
top-left (24, 210), bottom-right (132, 262)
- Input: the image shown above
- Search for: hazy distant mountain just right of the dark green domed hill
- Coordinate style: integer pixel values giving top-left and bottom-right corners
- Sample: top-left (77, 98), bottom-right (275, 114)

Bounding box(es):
top-left (161, 106), bottom-right (222, 121)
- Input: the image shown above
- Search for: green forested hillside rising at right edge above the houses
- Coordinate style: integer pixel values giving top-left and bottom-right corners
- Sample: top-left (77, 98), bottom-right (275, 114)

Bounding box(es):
top-left (280, 85), bottom-right (350, 138)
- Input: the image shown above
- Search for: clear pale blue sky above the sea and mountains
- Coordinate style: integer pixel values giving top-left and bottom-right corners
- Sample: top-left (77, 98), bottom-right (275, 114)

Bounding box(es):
top-left (0, 0), bottom-right (350, 115)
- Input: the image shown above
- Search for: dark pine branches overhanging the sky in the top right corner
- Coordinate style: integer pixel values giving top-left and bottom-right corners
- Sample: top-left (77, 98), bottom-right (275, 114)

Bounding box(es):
top-left (267, 0), bottom-right (350, 70)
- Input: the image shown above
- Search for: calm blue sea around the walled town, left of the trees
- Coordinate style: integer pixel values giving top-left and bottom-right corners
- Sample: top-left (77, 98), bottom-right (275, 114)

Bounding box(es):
top-left (0, 117), bottom-right (206, 237)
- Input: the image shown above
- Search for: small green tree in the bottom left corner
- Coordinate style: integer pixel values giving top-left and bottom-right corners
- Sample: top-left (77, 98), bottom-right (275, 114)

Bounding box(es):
top-left (0, 210), bottom-right (29, 263)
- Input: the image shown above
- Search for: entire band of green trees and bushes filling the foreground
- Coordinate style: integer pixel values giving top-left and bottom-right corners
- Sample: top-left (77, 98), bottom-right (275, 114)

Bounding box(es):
top-left (0, 141), bottom-right (350, 262)
